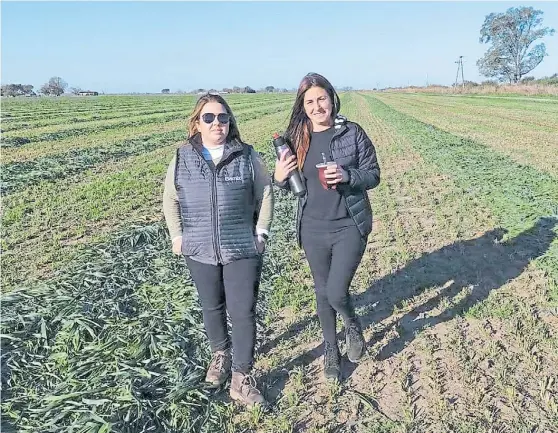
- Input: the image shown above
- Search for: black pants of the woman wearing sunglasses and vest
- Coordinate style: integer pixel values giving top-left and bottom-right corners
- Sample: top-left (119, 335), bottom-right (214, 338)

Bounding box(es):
top-left (186, 257), bottom-right (262, 373)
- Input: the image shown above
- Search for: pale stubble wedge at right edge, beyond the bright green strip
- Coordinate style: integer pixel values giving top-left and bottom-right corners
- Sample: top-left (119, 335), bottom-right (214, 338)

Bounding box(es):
top-left (376, 93), bottom-right (558, 179)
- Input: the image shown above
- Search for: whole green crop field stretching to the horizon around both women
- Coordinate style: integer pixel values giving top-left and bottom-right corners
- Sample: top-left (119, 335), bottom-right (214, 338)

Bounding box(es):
top-left (0, 92), bottom-right (558, 433)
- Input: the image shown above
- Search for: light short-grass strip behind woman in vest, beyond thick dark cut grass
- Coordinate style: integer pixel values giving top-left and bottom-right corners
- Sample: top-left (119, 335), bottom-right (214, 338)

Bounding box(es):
top-left (2, 104), bottom-right (296, 290)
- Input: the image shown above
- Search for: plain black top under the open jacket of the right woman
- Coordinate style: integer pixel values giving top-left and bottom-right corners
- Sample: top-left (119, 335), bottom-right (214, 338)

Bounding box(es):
top-left (302, 127), bottom-right (354, 231)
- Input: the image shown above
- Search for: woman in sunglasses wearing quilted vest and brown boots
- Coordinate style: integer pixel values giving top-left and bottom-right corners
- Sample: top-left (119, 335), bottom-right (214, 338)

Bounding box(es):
top-left (163, 94), bottom-right (273, 406)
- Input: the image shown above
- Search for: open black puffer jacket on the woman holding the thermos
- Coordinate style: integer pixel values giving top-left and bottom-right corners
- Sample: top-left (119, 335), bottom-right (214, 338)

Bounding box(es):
top-left (275, 115), bottom-right (380, 246)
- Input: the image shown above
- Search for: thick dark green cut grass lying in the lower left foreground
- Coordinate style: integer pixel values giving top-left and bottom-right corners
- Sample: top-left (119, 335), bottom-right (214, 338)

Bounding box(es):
top-left (2, 94), bottom-right (306, 432)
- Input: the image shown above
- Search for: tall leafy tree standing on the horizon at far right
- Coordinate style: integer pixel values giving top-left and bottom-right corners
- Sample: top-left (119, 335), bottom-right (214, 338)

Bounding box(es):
top-left (477, 7), bottom-right (554, 83)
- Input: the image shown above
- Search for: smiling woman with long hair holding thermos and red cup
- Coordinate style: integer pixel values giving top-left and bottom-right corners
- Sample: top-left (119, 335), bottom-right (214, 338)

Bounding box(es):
top-left (274, 73), bottom-right (380, 379)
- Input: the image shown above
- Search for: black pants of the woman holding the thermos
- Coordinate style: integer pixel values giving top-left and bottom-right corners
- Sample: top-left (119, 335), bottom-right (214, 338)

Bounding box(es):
top-left (301, 221), bottom-right (366, 344)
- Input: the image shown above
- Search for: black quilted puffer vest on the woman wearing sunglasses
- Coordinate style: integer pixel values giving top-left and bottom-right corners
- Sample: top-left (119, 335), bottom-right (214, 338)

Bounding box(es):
top-left (174, 136), bottom-right (258, 265)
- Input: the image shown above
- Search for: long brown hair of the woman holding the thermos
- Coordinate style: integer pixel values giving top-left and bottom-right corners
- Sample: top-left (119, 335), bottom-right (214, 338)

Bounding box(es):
top-left (285, 72), bottom-right (341, 169)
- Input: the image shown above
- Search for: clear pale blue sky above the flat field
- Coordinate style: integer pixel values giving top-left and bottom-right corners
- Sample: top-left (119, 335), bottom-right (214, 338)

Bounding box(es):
top-left (1, 1), bottom-right (558, 93)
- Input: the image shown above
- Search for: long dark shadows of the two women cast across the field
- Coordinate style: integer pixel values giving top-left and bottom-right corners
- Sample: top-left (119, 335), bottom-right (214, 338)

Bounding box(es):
top-left (259, 218), bottom-right (558, 400)
